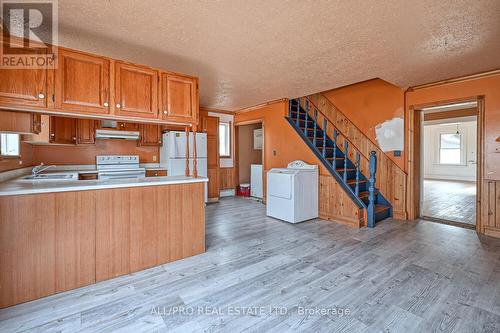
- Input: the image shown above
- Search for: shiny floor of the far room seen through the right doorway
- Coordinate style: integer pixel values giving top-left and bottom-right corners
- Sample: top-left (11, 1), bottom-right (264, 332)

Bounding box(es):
top-left (422, 179), bottom-right (476, 225)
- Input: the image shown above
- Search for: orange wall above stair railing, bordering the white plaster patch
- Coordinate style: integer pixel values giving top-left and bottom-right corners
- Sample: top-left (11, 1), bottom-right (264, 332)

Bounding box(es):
top-left (322, 79), bottom-right (405, 170)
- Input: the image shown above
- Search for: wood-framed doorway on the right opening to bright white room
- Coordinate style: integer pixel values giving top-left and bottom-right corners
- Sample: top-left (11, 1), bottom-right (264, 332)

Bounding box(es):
top-left (408, 97), bottom-right (484, 230)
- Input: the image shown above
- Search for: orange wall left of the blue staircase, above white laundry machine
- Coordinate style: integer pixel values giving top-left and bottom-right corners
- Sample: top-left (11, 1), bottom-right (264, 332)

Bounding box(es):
top-left (235, 102), bottom-right (328, 174)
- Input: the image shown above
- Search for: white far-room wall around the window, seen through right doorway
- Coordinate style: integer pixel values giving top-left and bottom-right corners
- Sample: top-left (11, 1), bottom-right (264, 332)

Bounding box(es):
top-left (422, 120), bottom-right (477, 181)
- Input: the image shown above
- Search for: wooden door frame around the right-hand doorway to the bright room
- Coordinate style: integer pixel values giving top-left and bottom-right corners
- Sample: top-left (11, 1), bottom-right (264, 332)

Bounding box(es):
top-left (406, 96), bottom-right (484, 233)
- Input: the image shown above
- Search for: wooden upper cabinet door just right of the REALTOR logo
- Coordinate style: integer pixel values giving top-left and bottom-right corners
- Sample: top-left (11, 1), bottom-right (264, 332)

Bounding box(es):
top-left (55, 49), bottom-right (109, 114)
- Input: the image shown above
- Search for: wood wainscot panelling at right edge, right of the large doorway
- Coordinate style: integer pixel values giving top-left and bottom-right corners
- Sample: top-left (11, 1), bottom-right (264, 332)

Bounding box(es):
top-left (481, 180), bottom-right (500, 237)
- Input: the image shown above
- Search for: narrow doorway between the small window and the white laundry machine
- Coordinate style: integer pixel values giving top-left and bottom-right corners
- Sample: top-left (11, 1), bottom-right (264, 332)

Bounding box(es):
top-left (235, 121), bottom-right (264, 200)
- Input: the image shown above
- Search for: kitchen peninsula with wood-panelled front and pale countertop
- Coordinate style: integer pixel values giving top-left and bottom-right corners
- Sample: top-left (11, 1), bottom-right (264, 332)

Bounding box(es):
top-left (0, 176), bottom-right (207, 307)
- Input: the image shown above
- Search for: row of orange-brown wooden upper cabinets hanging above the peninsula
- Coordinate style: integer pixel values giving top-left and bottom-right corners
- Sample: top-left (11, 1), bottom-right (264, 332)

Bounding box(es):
top-left (0, 45), bottom-right (199, 125)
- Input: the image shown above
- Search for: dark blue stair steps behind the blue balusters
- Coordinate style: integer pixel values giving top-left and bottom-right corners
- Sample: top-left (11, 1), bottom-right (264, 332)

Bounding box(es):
top-left (286, 99), bottom-right (392, 227)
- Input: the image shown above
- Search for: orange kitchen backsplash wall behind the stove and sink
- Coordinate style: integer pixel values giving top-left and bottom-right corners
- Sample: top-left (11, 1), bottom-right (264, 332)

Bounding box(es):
top-left (33, 140), bottom-right (159, 165)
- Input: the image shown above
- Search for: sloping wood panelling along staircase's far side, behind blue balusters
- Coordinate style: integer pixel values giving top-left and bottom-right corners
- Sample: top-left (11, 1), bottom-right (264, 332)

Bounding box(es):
top-left (308, 94), bottom-right (407, 219)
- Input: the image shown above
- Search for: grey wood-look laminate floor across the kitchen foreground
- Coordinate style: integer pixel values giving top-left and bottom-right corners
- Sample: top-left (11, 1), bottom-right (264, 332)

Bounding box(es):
top-left (0, 198), bottom-right (500, 333)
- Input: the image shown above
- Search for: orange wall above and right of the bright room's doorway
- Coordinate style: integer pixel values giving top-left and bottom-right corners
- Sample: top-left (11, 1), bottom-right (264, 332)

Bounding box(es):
top-left (406, 74), bottom-right (500, 180)
